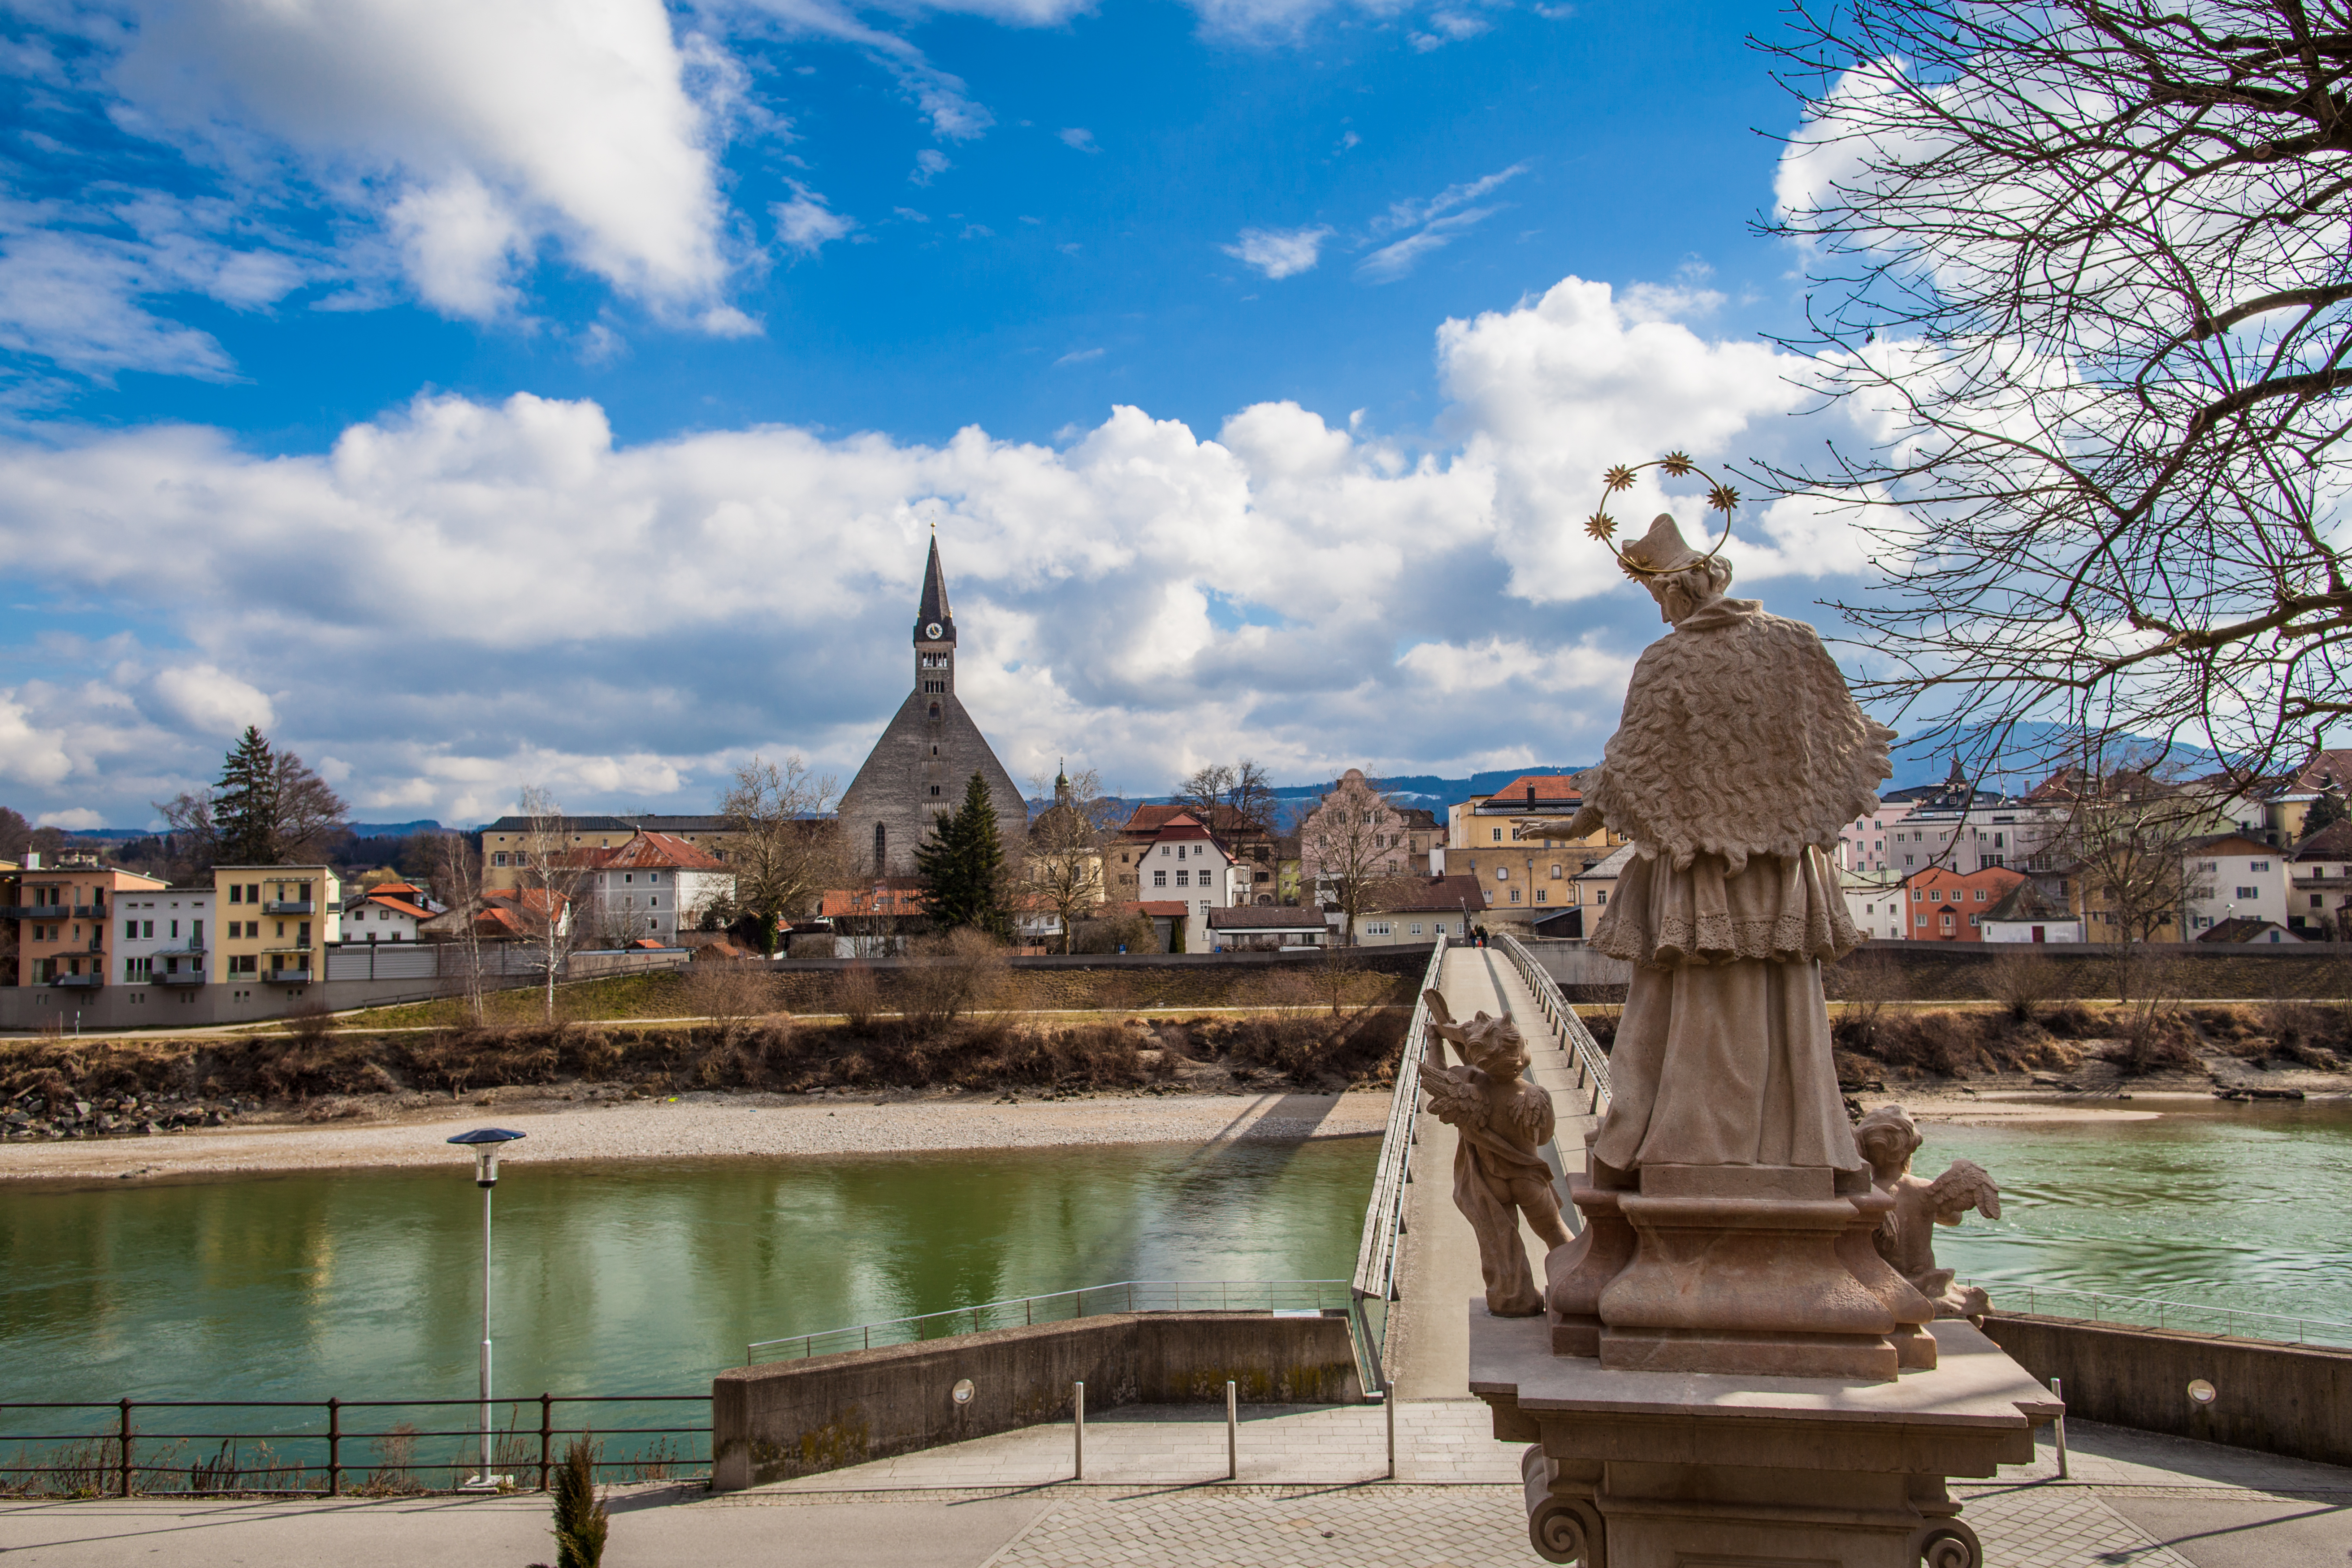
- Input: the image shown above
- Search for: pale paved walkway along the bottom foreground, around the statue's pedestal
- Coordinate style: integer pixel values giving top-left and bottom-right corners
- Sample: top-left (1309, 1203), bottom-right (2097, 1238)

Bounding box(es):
top-left (0, 1401), bottom-right (2352, 1568)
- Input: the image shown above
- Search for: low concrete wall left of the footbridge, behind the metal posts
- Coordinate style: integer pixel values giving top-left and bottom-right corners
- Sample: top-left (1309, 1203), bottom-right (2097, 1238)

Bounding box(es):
top-left (710, 1312), bottom-right (1364, 1493)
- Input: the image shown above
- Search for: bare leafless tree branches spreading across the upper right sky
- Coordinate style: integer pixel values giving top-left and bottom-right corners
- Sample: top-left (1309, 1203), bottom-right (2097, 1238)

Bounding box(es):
top-left (1759, 0), bottom-right (2352, 783)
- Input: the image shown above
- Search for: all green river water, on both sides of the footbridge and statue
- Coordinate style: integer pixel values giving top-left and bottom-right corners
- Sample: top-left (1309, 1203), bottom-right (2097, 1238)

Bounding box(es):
top-left (0, 1105), bottom-right (2352, 1401)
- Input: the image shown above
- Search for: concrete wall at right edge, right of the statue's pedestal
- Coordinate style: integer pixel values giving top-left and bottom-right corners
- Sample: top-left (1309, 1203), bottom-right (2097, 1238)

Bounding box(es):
top-left (1985, 1312), bottom-right (2352, 1464)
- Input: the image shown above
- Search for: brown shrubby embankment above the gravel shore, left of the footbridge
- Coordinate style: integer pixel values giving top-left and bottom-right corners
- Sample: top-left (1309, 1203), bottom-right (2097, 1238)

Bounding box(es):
top-left (0, 1006), bottom-right (1407, 1138)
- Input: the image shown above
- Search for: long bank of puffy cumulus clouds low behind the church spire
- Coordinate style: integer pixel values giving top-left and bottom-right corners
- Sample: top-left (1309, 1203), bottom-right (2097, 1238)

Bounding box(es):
top-left (0, 273), bottom-right (1891, 823)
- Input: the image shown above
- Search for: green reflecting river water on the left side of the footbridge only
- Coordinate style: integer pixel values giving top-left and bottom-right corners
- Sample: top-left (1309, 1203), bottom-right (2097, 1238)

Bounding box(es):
top-left (0, 1138), bottom-right (1378, 1399)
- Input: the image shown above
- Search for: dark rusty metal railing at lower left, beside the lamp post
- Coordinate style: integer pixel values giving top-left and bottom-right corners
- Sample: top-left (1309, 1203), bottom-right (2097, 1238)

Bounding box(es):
top-left (0, 1394), bottom-right (710, 1498)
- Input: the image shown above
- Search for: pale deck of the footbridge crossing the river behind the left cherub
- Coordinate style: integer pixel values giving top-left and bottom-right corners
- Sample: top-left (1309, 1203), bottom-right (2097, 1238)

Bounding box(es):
top-left (1388, 947), bottom-right (1592, 1401)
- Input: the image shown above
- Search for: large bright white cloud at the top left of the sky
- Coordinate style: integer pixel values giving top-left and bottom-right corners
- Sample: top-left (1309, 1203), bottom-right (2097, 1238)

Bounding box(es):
top-left (108, 0), bottom-right (729, 315)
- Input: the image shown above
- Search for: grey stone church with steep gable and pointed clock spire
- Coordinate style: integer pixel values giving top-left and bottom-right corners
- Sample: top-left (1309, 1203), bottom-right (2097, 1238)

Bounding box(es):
top-left (840, 533), bottom-right (1028, 877)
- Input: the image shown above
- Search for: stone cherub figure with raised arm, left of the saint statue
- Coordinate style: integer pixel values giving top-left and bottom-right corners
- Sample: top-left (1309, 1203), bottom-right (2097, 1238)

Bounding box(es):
top-left (1421, 990), bottom-right (1569, 1317)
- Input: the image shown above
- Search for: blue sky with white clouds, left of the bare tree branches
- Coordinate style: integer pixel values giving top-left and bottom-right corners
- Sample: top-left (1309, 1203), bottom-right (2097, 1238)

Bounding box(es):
top-left (0, 0), bottom-right (1891, 825)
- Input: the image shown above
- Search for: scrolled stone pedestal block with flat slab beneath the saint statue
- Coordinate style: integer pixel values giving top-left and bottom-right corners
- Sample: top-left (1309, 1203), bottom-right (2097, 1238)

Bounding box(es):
top-left (1470, 1307), bottom-right (2060, 1568)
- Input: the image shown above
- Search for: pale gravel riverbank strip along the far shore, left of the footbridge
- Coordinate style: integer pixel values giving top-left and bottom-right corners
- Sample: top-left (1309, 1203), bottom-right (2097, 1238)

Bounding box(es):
top-left (0, 1088), bottom-right (1388, 1180)
